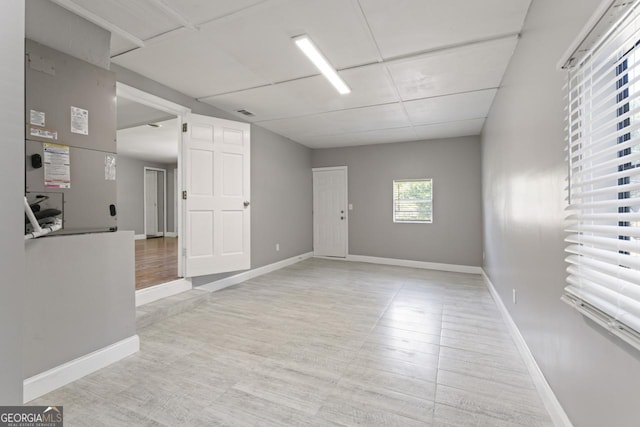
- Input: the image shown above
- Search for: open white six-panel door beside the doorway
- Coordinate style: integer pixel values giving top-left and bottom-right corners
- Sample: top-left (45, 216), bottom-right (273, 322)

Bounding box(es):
top-left (183, 114), bottom-right (251, 277)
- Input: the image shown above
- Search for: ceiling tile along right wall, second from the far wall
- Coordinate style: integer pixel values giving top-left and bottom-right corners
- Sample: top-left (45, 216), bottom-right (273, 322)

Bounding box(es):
top-left (404, 89), bottom-right (497, 125)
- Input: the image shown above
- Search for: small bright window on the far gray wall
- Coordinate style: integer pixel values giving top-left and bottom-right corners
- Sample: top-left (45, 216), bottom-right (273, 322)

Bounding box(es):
top-left (393, 179), bottom-right (433, 223)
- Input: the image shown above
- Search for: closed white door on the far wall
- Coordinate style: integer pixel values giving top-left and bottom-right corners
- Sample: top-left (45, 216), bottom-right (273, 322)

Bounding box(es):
top-left (313, 167), bottom-right (348, 258)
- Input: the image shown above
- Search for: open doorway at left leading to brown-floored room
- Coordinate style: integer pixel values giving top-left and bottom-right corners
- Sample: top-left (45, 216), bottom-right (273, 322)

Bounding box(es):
top-left (117, 83), bottom-right (190, 294)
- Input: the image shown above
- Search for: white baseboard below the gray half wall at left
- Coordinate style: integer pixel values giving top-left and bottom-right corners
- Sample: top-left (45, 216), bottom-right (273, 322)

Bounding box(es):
top-left (23, 335), bottom-right (140, 403)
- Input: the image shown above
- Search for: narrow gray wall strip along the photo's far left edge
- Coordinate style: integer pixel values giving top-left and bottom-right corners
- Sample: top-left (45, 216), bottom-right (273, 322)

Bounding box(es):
top-left (0, 0), bottom-right (25, 405)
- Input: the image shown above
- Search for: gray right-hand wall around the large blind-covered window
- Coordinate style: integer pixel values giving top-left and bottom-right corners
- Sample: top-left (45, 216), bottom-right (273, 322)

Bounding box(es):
top-left (482, 0), bottom-right (640, 427)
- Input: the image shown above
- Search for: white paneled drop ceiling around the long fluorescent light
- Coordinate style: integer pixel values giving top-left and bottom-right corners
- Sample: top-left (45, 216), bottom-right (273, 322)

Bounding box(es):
top-left (53, 0), bottom-right (530, 148)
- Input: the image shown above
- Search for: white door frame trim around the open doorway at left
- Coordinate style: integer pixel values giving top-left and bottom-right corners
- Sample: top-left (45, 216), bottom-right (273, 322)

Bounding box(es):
top-left (116, 82), bottom-right (191, 277)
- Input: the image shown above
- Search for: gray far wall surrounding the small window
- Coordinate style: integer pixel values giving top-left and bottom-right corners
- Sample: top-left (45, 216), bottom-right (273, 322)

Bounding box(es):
top-left (312, 137), bottom-right (482, 266)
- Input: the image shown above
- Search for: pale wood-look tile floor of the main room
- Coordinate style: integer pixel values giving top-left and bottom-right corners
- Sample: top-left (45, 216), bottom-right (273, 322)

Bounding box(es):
top-left (31, 259), bottom-right (552, 427)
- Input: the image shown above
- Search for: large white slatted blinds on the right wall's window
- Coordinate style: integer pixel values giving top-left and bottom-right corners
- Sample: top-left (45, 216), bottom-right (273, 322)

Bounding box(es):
top-left (563, 1), bottom-right (640, 348)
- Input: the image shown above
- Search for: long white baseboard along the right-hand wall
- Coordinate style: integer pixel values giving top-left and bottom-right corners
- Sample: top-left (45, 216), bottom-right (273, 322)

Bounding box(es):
top-left (482, 270), bottom-right (573, 427)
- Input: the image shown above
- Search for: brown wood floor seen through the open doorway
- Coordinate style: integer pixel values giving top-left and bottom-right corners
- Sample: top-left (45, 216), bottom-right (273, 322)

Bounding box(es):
top-left (135, 237), bottom-right (178, 289)
